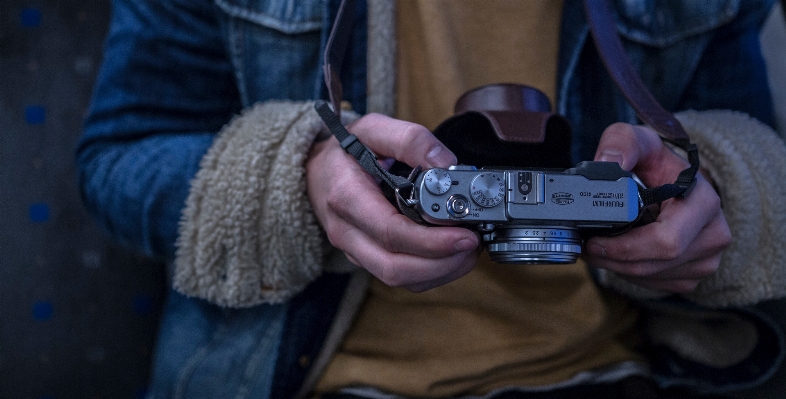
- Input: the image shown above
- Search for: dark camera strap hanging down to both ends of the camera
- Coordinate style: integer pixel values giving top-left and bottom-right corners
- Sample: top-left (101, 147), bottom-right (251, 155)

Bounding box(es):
top-left (314, 0), bottom-right (699, 206)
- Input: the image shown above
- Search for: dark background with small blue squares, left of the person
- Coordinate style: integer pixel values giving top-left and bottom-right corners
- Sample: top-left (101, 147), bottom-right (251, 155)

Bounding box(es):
top-left (0, 0), bottom-right (164, 399)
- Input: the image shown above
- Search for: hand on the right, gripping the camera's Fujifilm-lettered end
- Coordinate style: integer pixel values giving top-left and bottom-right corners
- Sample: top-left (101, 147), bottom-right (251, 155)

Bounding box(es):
top-left (586, 123), bottom-right (731, 293)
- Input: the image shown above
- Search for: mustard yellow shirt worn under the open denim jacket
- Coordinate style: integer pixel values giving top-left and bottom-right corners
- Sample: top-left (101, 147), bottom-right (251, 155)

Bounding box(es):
top-left (317, 0), bottom-right (638, 397)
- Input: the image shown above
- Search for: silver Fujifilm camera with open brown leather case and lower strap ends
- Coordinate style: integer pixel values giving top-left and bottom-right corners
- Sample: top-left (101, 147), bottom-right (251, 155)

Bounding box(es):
top-left (315, 84), bottom-right (672, 264)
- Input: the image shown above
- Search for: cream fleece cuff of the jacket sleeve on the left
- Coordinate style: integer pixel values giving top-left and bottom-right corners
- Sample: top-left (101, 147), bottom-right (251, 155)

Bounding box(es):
top-left (174, 101), bottom-right (327, 307)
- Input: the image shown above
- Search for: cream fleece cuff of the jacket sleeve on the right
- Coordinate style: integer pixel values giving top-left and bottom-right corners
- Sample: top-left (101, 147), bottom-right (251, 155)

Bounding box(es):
top-left (599, 110), bottom-right (786, 308)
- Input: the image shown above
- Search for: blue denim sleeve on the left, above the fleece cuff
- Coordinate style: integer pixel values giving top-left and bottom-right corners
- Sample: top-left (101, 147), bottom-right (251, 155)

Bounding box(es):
top-left (76, 0), bottom-right (240, 258)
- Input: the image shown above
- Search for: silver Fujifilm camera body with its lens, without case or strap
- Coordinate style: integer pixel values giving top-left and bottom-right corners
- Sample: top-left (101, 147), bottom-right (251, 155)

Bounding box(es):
top-left (411, 162), bottom-right (643, 264)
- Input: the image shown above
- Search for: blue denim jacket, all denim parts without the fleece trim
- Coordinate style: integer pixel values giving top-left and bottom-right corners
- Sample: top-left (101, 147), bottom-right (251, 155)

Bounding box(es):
top-left (77, 0), bottom-right (780, 398)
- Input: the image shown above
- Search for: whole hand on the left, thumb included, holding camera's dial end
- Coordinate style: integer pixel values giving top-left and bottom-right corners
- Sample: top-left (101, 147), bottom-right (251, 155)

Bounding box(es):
top-left (306, 114), bottom-right (479, 291)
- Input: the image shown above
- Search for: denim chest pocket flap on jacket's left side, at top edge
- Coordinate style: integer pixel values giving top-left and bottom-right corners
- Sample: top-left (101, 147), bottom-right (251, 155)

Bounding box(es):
top-left (215, 0), bottom-right (322, 34)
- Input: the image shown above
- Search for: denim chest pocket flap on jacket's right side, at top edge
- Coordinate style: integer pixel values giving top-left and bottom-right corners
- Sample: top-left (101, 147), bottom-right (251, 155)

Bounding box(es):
top-left (614, 0), bottom-right (740, 48)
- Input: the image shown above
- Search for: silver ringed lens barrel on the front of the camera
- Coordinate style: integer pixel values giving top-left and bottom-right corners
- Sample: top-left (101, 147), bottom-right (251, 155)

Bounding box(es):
top-left (483, 226), bottom-right (581, 264)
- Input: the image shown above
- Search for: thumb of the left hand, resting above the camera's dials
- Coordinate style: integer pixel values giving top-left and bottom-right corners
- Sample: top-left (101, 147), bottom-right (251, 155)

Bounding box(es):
top-left (349, 114), bottom-right (456, 168)
